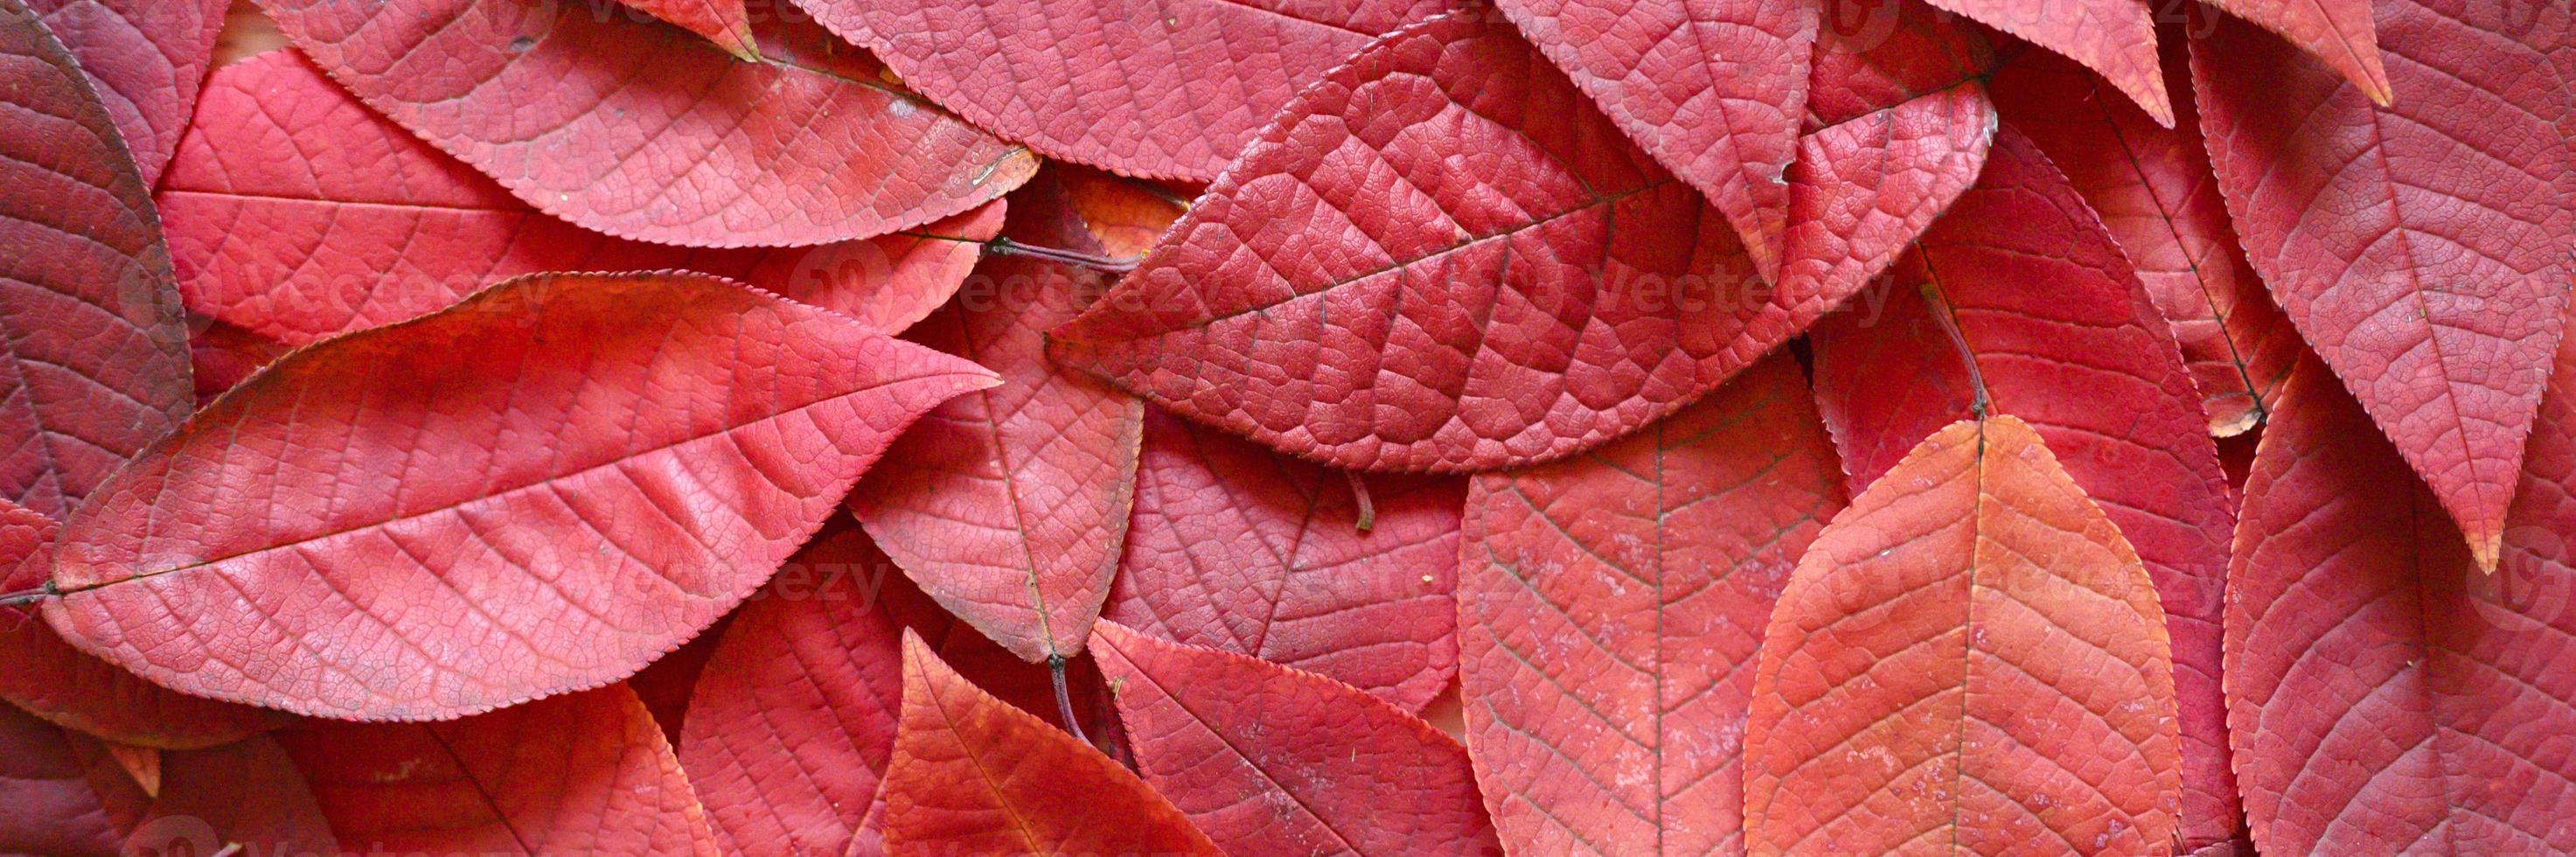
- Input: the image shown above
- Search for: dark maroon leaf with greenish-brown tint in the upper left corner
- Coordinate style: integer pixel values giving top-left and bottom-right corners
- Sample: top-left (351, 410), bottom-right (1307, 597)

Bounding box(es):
top-left (0, 0), bottom-right (191, 518)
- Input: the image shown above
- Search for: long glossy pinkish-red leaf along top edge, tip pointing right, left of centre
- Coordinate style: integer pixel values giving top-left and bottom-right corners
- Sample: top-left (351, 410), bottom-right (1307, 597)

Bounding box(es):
top-left (261, 0), bottom-right (1035, 247)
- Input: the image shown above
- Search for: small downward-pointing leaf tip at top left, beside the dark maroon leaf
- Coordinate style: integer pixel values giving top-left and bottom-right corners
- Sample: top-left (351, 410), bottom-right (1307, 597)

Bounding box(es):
top-left (25, 0), bottom-right (229, 188)
